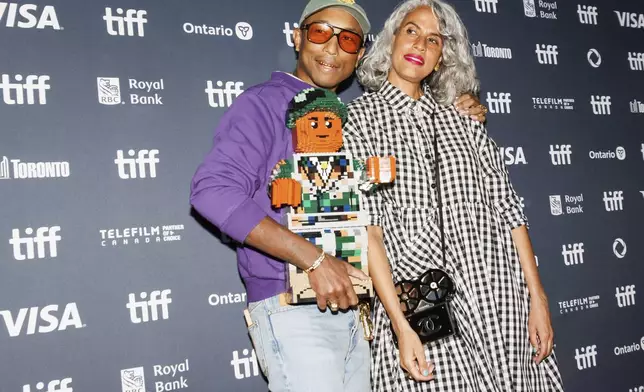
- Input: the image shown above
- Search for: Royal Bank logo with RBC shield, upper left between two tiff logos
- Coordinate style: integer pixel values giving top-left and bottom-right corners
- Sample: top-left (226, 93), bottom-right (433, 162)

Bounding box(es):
top-left (96, 76), bottom-right (165, 105)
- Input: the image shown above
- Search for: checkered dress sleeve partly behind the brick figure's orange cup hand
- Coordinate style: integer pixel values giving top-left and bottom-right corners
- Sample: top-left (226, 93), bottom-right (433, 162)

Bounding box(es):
top-left (342, 105), bottom-right (383, 226)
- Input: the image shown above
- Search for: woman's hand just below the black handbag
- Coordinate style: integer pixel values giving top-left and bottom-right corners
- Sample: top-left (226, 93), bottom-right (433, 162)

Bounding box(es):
top-left (396, 324), bottom-right (434, 381)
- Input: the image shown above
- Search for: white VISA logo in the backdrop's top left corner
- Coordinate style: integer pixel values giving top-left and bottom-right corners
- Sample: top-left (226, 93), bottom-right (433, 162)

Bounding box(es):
top-left (0, 3), bottom-right (63, 30)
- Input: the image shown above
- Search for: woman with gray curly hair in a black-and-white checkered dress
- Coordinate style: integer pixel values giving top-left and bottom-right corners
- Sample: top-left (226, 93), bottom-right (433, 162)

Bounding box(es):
top-left (344, 0), bottom-right (563, 392)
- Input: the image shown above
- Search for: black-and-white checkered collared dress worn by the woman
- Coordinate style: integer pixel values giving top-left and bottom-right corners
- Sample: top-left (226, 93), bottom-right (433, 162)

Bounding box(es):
top-left (343, 83), bottom-right (563, 392)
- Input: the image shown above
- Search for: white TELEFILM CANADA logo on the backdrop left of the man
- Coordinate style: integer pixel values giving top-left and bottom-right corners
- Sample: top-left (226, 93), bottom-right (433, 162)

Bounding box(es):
top-left (98, 224), bottom-right (185, 248)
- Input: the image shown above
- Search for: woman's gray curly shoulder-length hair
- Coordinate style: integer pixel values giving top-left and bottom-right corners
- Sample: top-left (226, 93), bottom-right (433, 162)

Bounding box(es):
top-left (357, 0), bottom-right (479, 105)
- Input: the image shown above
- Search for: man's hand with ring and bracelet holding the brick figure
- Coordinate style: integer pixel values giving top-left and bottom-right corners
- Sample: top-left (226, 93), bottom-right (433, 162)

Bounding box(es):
top-left (309, 255), bottom-right (369, 311)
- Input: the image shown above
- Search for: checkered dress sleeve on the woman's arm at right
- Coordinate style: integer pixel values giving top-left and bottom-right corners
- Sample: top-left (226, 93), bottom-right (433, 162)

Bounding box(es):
top-left (471, 121), bottom-right (528, 229)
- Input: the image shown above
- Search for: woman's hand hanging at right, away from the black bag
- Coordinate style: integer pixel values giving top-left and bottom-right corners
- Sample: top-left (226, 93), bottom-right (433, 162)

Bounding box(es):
top-left (528, 294), bottom-right (554, 363)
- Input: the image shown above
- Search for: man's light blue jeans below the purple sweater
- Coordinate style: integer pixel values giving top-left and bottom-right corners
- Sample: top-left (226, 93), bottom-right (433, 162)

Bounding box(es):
top-left (248, 296), bottom-right (371, 392)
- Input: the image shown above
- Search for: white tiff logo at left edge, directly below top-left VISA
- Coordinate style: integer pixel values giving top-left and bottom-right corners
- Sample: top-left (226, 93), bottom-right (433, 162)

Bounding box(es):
top-left (0, 74), bottom-right (51, 105)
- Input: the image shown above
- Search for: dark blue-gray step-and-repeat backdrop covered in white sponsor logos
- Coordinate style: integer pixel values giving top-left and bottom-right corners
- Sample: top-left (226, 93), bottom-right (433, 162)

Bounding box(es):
top-left (0, 0), bottom-right (644, 392)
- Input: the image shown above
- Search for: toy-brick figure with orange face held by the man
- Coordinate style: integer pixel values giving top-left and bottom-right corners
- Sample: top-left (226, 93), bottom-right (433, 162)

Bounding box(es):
top-left (269, 88), bottom-right (395, 304)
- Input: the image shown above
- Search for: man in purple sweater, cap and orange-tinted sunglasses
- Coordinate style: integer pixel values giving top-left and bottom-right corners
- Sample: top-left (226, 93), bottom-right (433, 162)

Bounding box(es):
top-left (190, 0), bottom-right (486, 392)
